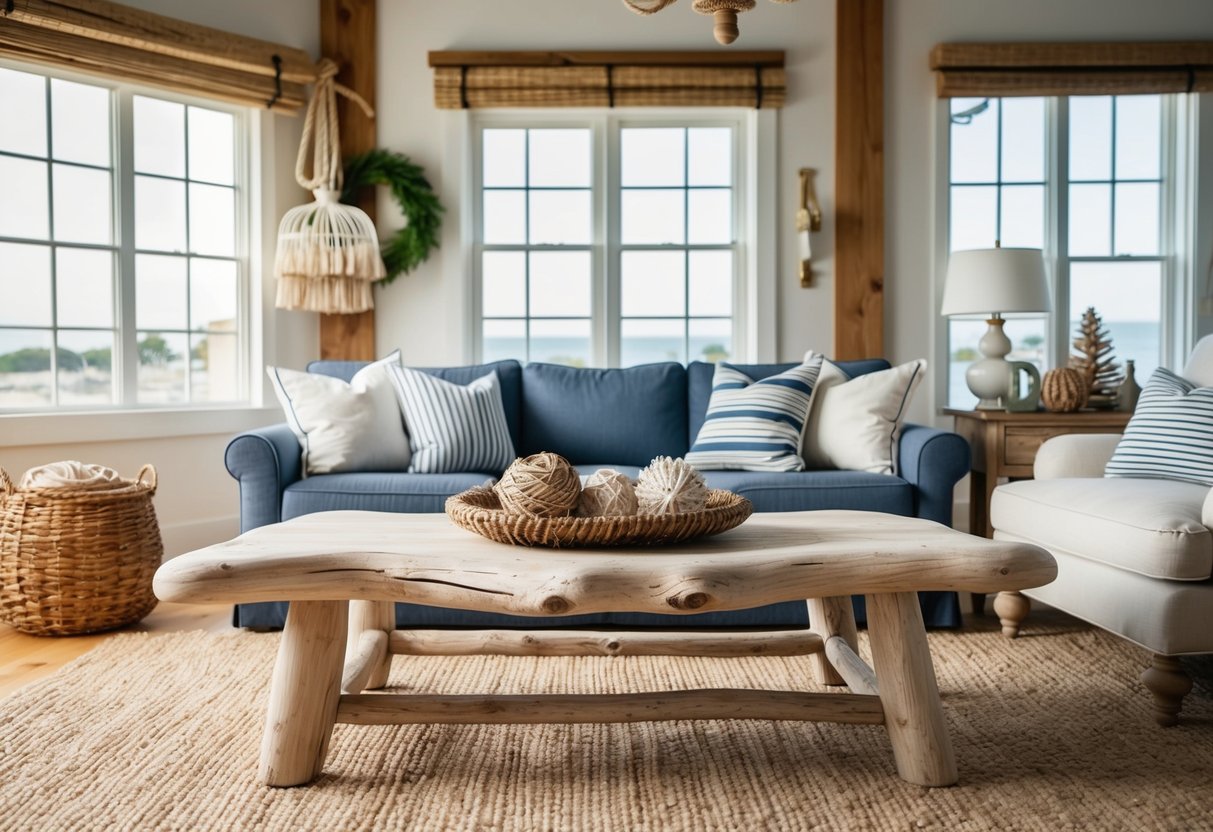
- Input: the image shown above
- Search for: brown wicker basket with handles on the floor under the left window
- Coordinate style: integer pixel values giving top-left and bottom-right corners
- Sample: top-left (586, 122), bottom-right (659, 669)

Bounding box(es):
top-left (0, 465), bottom-right (164, 636)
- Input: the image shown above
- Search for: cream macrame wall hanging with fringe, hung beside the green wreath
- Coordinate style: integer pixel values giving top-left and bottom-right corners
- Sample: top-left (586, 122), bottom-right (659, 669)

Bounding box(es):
top-left (274, 58), bottom-right (386, 313)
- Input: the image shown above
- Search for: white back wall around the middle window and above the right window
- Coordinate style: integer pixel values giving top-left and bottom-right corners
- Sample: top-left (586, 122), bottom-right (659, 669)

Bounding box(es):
top-left (376, 0), bottom-right (1213, 424)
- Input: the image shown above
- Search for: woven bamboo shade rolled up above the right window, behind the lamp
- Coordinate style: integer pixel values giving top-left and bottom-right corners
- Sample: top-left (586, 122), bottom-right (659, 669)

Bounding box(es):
top-left (930, 41), bottom-right (1213, 98)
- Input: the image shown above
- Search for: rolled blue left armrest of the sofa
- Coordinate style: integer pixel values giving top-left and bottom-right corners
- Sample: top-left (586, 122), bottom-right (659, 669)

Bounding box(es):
top-left (223, 423), bottom-right (303, 532)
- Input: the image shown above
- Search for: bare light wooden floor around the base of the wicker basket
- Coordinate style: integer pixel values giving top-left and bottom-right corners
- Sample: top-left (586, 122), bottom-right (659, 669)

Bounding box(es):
top-left (0, 604), bottom-right (232, 699)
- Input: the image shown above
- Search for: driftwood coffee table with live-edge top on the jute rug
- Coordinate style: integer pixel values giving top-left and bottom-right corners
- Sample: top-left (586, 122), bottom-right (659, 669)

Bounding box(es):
top-left (155, 512), bottom-right (1057, 786)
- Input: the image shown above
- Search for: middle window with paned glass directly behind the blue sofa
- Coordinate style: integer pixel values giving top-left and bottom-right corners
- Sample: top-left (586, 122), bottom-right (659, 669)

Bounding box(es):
top-left (475, 115), bottom-right (742, 366)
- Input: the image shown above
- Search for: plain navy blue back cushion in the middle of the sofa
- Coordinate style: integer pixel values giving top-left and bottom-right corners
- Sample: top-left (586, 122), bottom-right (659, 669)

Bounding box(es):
top-left (518, 363), bottom-right (688, 466)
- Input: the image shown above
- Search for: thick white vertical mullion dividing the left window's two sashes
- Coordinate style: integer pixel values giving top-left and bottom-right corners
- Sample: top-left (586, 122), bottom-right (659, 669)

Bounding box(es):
top-left (113, 90), bottom-right (139, 405)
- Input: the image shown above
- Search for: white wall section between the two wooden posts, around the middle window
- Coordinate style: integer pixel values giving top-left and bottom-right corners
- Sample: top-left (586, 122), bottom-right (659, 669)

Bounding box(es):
top-left (376, 0), bottom-right (835, 364)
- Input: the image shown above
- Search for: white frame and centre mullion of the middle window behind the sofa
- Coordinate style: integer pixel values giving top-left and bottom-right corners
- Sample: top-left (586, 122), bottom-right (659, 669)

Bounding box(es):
top-left (462, 108), bottom-right (756, 367)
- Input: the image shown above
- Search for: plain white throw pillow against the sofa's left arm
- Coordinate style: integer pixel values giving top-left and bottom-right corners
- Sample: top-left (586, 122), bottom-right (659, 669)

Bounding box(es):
top-left (266, 351), bottom-right (410, 477)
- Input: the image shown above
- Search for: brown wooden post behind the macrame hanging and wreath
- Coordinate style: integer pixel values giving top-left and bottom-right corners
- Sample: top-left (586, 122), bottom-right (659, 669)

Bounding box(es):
top-left (320, 0), bottom-right (376, 361)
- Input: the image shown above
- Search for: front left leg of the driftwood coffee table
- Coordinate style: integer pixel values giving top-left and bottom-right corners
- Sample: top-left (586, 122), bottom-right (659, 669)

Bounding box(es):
top-left (257, 600), bottom-right (349, 786)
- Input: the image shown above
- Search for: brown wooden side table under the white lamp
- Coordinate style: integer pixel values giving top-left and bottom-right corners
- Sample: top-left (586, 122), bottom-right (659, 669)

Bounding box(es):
top-left (944, 408), bottom-right (1132, 537)
